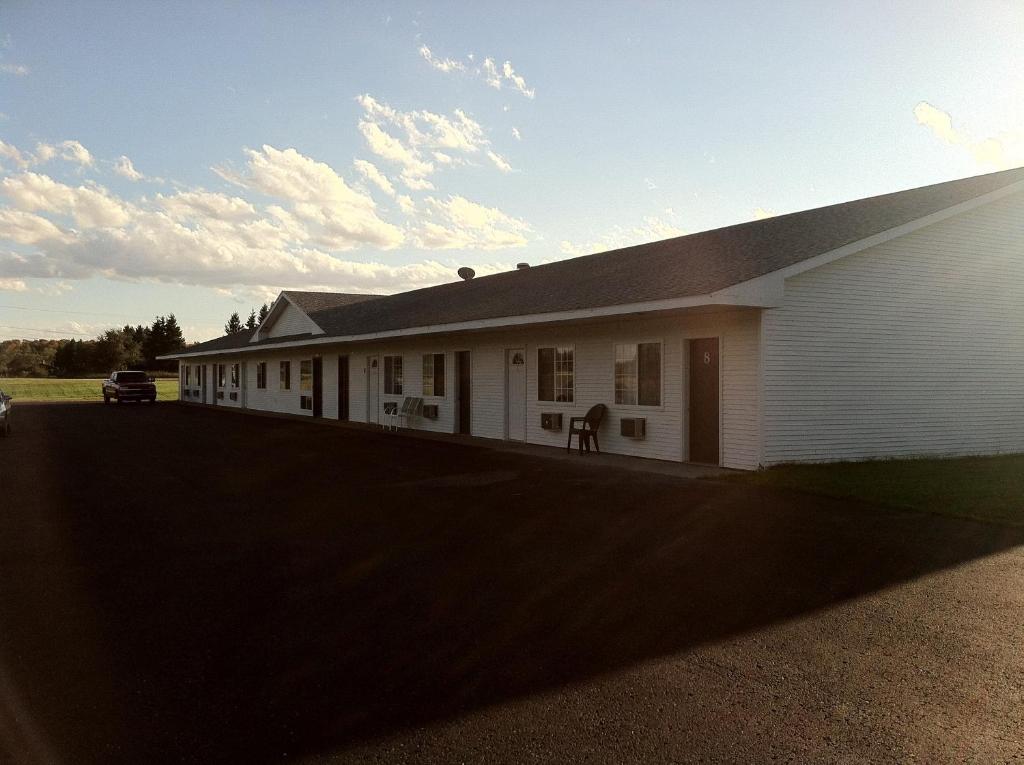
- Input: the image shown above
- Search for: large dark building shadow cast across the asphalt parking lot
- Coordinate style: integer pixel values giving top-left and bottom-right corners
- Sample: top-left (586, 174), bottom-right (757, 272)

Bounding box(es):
top-left (0, 405), bottom-right (1024, 762)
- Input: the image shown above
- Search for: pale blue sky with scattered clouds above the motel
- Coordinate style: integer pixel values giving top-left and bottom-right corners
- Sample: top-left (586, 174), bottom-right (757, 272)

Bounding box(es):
top-left (0, 0), bottom-right (1024, 340)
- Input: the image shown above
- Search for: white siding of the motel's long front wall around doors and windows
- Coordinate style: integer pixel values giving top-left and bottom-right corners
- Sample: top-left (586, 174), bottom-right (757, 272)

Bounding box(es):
top-left (182, 309), bottom-right (760, 469)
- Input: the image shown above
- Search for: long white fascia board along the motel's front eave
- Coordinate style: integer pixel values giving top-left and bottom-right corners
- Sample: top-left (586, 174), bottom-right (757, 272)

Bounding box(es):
top-left (158, 290), bottom-right (781, 358)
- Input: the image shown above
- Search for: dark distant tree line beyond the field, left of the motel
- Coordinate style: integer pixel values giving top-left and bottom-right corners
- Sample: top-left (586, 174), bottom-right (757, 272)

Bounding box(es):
top-left (0, 313), bottom-right (185, 377)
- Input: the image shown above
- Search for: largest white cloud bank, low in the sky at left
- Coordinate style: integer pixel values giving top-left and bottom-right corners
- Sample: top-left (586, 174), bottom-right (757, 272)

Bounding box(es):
top-left (0, 136), bottom-right (530, 293)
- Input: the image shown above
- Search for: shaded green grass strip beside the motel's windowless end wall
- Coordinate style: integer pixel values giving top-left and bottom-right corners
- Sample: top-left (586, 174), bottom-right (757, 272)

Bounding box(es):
top-left (737, 455), bottom-right (1024, 525)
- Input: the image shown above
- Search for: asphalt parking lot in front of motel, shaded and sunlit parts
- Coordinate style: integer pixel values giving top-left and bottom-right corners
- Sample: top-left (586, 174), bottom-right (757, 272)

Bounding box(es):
top-left (0, 403), bottom-right (1024, 763)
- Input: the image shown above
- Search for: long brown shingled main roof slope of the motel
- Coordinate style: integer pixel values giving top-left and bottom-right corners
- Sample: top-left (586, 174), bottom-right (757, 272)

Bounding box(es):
top-left (176, 168), bottom-right (1024, 353)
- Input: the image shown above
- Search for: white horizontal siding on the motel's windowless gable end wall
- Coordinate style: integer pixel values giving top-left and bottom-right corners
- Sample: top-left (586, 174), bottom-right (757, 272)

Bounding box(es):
top-left (761, 194), bottom-right (1024, 464)
